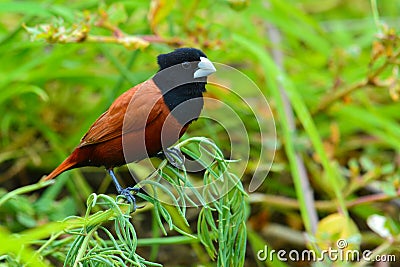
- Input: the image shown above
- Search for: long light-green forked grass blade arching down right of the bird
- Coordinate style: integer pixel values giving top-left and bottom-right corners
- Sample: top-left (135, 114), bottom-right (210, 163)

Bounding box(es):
top-left (233, 34), bottom-right (348, 222)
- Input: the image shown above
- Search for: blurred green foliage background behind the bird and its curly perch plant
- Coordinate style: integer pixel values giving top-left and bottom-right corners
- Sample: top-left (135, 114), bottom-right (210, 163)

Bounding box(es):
top-left (0, 0), bottom-right (400, 266)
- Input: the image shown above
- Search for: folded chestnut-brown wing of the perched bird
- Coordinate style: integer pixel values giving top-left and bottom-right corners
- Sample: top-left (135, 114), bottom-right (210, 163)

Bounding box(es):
top-left (79, 80), bottom-right (162, 147)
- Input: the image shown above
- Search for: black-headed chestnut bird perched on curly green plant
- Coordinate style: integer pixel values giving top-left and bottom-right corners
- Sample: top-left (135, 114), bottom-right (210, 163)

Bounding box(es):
top-left (44, 48), bottom-right (216, 208)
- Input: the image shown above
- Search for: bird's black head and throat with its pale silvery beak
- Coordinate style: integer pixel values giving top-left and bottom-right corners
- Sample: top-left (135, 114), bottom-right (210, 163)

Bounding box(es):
top-left (153, 48), bottom-right (216, 125)
